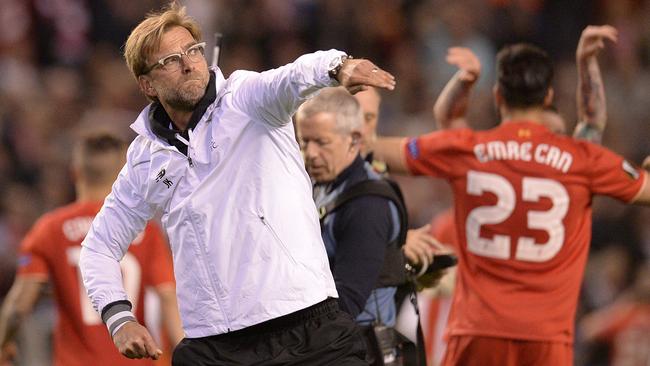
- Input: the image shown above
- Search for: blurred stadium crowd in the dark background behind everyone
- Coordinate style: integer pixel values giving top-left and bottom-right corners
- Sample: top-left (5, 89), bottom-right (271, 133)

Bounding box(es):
top-left (0, 0), bottom-right (650, 364)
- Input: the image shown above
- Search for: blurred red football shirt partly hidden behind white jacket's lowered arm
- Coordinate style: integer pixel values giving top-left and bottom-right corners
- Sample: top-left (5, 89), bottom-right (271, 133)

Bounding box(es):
top-left (17, 202), bottom-right (174, 366)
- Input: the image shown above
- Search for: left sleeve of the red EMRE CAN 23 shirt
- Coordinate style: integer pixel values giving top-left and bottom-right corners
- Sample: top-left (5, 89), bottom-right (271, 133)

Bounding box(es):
top-left (404, 129), bottom-right (470, 177)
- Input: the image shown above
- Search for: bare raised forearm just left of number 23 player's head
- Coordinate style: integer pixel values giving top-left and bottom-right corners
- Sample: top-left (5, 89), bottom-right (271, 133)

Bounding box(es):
top-left (433, 47), bottom-right (481, 130)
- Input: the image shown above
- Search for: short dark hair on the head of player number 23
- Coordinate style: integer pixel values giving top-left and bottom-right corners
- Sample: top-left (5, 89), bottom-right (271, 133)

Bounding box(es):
top-left (497, 43), bottom-right (553, 109)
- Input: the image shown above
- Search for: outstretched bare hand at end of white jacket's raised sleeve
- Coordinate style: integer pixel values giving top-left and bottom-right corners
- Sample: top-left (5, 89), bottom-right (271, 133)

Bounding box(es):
top-left (336, 58), bottom-right (395, 94)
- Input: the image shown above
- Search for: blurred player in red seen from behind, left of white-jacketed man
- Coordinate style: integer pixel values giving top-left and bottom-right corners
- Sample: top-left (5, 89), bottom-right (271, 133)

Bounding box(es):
top-left (0, 132), bottom-right (183, 366)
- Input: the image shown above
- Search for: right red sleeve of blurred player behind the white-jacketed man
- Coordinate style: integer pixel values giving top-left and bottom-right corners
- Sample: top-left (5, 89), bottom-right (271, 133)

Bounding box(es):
top-left (142, 222), bottom-right (174, 287)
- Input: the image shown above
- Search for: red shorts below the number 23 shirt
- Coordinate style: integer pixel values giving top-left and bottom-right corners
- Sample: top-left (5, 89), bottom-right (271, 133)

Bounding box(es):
top-left (442, 336), bottom-right (573, 366)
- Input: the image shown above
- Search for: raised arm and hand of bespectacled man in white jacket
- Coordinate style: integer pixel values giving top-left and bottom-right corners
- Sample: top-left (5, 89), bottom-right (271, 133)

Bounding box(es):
top-left (231, 50), bottom-right (395, 126)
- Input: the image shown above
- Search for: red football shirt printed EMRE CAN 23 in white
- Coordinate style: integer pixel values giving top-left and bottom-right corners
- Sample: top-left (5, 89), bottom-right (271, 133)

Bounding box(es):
top-left (404, 121), bottom-right (646, 343)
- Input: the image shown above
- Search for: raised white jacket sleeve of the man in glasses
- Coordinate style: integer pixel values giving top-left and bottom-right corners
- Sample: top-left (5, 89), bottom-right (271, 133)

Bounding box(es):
top-left (228, 50), bottom-right (345, 126)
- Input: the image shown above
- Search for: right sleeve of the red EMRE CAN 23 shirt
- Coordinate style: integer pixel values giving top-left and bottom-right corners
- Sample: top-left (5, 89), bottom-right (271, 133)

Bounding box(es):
top-left (585, 143), bottom-right (647, 202)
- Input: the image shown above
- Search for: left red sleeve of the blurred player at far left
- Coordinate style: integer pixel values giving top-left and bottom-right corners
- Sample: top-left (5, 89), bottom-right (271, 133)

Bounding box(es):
top-left (17, 219), bottom-right (53, 279)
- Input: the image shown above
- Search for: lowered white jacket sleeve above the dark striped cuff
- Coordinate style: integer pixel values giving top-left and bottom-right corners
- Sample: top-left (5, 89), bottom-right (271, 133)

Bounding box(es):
top-left (79, 139), bottom-right (154, 313)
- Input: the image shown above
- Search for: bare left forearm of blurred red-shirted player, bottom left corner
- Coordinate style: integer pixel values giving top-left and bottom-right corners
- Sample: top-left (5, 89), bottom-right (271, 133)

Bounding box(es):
top-left (0, 276), bottom-right (47, 364)
